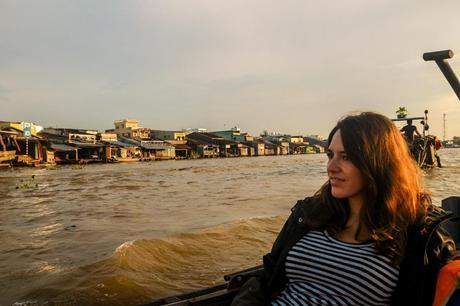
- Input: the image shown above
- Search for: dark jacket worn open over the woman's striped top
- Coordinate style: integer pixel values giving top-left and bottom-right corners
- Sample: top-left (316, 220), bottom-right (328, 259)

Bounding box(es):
top-left (232, 198), bottom-right (455, 306)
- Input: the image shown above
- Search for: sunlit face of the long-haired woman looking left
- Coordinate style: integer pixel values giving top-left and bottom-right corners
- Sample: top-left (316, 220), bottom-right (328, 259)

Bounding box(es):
top-left (327, 130), bottom-right (366, 200)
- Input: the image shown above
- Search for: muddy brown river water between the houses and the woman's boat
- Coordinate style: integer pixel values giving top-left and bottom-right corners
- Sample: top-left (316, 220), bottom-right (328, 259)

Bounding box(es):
top-left (0, 149), bottom-right (460, 306)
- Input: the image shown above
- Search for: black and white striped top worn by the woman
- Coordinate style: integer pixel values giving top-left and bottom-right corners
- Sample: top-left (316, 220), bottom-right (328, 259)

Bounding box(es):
top-left (272, 231), bottom-right (399, 306)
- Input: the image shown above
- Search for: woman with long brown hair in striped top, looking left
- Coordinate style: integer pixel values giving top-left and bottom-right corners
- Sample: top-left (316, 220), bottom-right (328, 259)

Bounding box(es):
top-left (232, 112), bottom-right (455, 306)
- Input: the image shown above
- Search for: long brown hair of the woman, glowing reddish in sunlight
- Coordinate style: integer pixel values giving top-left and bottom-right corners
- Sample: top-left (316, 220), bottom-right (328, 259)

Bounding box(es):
top-left (316, 112), bottom-right (430, 264)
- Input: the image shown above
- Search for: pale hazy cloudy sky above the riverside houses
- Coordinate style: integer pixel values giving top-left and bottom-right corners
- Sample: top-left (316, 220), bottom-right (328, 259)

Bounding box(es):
top-left (0, 0), bottom-right (460, 138)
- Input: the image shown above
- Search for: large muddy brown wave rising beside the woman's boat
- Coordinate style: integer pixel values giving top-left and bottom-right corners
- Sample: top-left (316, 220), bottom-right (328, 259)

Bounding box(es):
top-left (11, 217), bottom-right (285, 305)
